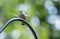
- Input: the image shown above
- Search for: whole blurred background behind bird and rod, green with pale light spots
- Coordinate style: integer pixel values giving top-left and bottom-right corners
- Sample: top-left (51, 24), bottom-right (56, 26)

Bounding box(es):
top-left (0, 0), bottom-right (60, 39)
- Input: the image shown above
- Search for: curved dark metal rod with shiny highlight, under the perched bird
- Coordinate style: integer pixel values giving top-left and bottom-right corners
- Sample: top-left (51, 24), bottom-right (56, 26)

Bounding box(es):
top-left (0, 18), bottom-right (38, 39)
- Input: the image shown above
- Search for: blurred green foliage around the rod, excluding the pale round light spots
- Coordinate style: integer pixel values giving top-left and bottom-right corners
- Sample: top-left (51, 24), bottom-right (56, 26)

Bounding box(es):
top-left (0, 0), bottom-right (60, 39)
